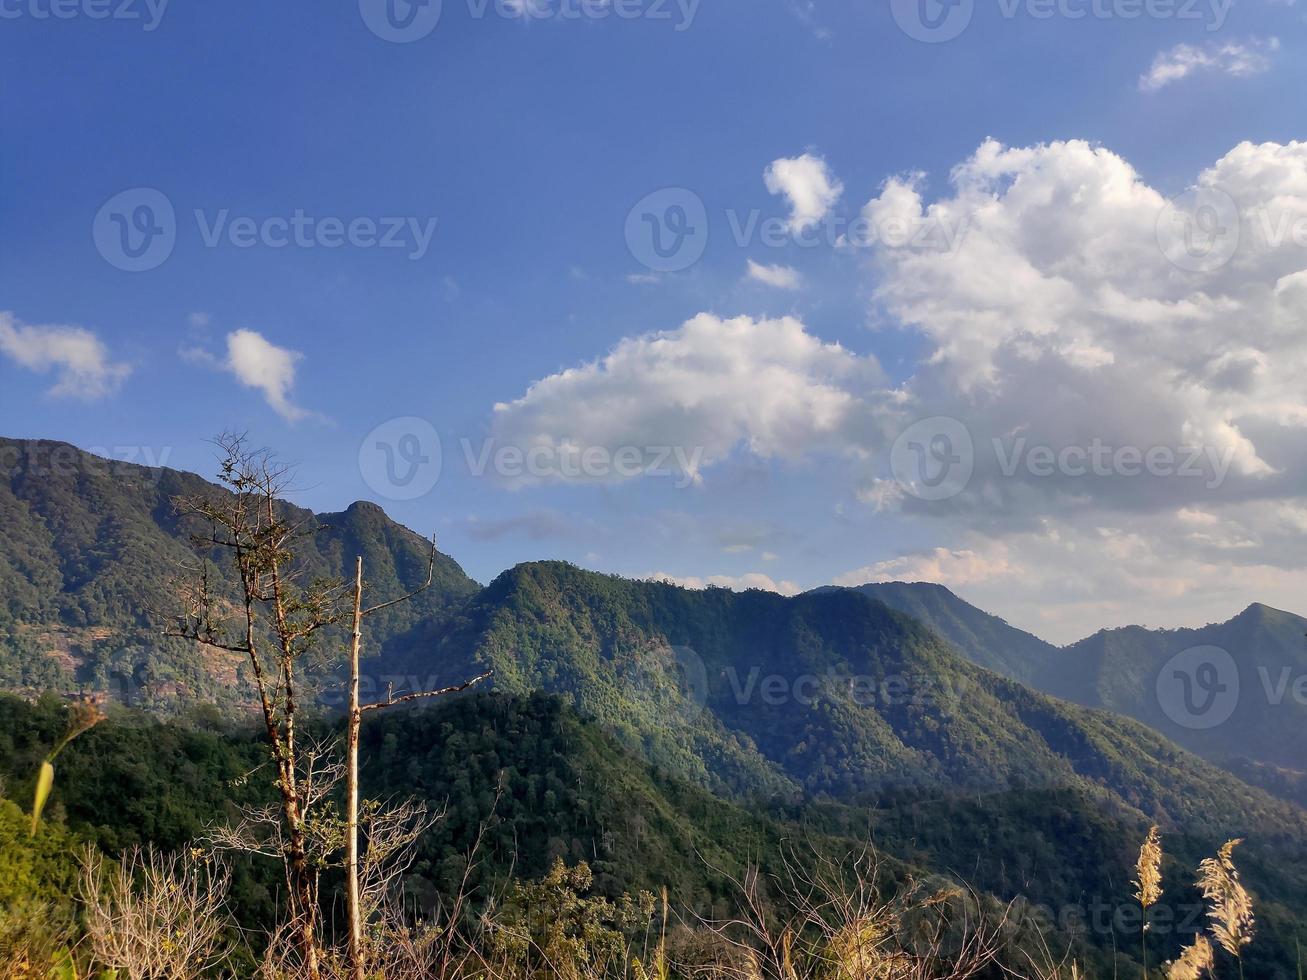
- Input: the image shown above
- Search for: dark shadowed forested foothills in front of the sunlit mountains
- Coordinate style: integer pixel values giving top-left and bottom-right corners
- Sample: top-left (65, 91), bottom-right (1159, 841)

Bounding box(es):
top-left (0, 694), bottom-right (1293, 980)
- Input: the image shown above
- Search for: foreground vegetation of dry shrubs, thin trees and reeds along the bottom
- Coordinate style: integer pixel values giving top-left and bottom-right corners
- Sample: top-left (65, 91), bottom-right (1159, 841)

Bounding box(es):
top-left (0, 438), bottom-right (1296, 980)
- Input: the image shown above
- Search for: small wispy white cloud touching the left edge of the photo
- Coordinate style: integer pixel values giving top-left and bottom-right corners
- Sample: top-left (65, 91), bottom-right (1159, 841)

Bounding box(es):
top-left (0, 312), bottom-right (132, 400)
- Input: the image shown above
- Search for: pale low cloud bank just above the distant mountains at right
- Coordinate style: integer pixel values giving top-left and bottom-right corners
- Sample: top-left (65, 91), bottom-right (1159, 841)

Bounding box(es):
top-left (835, 504), bottom-right (1307, 643)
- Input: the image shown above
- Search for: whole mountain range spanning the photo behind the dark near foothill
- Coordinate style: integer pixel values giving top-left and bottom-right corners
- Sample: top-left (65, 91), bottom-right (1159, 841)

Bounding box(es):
top-left (0, 440), bottom-right (1307, 976)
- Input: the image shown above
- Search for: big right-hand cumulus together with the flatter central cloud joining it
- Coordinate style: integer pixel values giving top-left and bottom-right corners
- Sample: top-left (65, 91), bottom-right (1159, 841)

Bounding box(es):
top-left (494, 140), bottom-right (1307, 639)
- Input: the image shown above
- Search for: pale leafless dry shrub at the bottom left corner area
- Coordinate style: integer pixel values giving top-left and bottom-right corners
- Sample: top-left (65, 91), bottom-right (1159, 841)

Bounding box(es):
top-left (81, 847), bottom-right (231, 980)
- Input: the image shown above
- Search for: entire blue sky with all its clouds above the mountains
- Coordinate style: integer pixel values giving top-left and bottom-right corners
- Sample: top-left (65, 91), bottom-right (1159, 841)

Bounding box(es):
top-left (0, 0), bottom-right (1307, 640)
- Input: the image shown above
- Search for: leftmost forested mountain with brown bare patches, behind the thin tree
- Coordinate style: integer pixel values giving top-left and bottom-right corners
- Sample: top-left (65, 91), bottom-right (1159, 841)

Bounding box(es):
top-left (0, 439), bottom-right (477, 708)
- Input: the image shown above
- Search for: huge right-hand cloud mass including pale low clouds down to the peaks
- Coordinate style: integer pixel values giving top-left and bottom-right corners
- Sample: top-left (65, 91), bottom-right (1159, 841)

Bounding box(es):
top-left (839, 141), bottom-right (1307, 640)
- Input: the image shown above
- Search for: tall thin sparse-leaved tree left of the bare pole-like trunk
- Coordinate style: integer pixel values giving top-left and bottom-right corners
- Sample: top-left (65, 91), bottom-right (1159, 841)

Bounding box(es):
top-left (169, 434), bottom-right (344, 980)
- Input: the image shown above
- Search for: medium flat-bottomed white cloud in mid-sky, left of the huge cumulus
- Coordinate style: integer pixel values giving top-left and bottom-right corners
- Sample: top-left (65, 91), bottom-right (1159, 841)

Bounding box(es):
top-left (491, 314), bottom-right (882, 480)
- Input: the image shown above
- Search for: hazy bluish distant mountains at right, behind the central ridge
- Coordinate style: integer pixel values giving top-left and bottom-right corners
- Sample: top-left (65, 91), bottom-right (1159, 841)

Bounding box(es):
top-left (836, 583), bottom-right (1307, 801)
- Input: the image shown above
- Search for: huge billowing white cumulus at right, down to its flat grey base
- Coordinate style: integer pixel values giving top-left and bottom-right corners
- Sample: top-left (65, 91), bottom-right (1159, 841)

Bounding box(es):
top-left (865, 141), bottom-right (1307, 516)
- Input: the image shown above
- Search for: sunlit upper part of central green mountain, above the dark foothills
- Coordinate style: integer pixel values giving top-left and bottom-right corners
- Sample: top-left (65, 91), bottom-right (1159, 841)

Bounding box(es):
top-left (392, 562), bottom-right (1303, 834)
